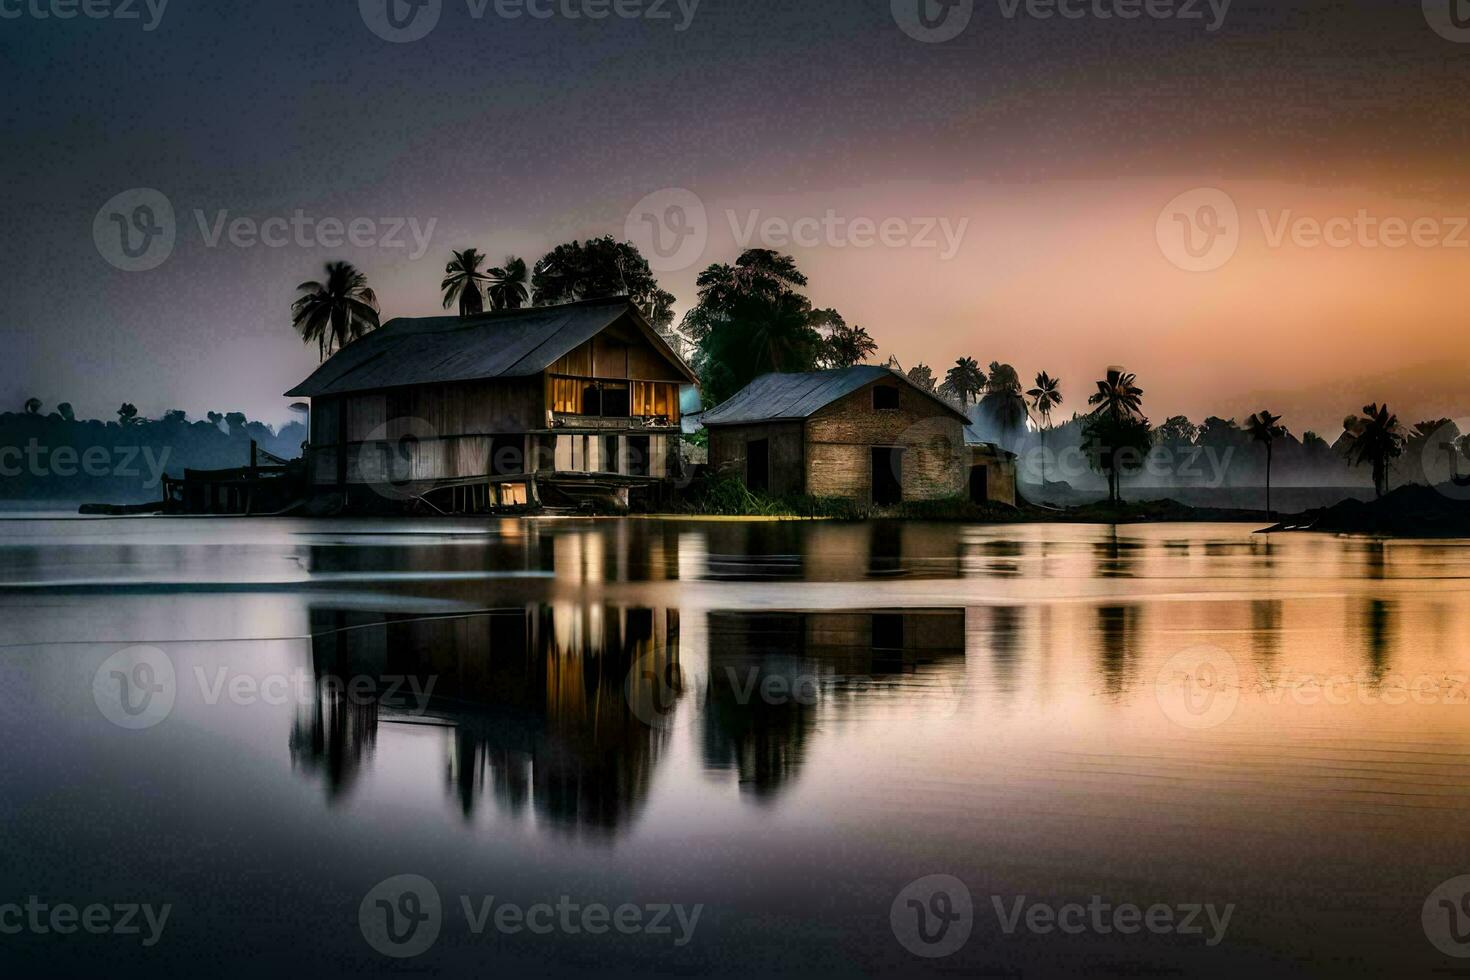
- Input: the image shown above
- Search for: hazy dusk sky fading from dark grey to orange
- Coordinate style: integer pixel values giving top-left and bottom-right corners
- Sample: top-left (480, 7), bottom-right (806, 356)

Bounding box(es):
top-left (0, 0), bottom-right (1470, 438)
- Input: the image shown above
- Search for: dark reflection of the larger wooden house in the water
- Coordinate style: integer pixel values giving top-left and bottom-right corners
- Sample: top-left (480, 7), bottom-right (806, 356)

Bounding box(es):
top-left (291, 604), bottom-right (679, 835)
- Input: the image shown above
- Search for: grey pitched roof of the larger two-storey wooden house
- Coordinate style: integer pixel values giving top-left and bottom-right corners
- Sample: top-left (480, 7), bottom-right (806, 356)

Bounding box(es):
top-left (285, 297), bottom-right (697, 398)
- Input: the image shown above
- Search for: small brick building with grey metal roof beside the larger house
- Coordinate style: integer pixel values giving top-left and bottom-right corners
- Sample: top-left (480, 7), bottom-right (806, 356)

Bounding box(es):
top-left (701, 364), bottom-right (1016, 507)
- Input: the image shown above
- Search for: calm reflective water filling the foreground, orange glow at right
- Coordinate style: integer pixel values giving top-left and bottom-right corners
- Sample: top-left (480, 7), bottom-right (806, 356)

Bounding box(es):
top-left (0, 519), bottom-right (1470, 977)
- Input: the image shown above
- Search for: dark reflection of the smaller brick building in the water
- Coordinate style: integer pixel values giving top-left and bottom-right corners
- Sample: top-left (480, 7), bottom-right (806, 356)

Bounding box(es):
top-left (701, 608), bottom-right (964, 801)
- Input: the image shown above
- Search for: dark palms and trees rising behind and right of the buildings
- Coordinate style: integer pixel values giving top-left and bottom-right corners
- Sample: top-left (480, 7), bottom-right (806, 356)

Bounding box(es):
top-left (273, 235), bottom-right (1470, 510)
